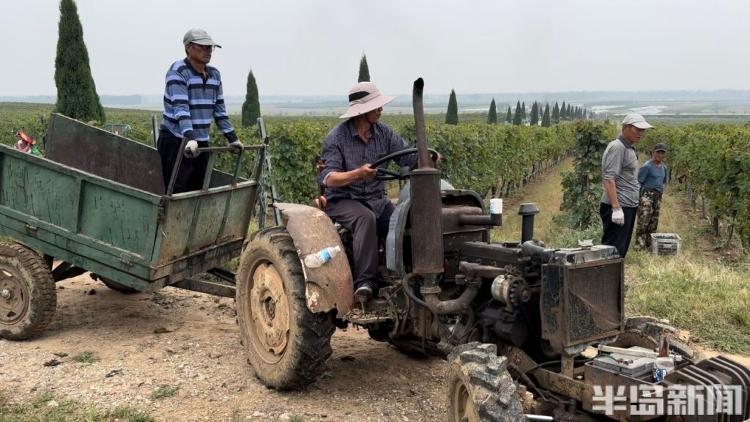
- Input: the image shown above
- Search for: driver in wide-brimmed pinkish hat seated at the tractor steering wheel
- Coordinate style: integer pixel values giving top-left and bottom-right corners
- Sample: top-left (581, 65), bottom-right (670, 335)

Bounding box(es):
top-left (318, 82), bottom-right (428, 302)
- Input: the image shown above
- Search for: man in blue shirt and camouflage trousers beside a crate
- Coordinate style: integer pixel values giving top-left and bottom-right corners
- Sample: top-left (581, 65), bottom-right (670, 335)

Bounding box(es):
top-left (635, 143), bottom-right (669, 249)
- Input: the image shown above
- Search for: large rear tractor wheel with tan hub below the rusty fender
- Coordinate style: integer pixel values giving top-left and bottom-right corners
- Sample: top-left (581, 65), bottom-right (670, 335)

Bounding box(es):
top-left (236, 227), bottom-right (335, 389)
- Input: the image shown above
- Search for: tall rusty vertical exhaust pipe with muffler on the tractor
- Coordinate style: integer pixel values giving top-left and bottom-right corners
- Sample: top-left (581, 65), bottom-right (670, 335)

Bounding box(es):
top-left (410, 78), bottom-right (443, 276)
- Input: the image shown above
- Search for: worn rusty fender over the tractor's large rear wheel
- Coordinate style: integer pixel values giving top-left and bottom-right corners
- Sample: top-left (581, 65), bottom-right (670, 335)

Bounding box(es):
top-left (274, 203), bottom-right (354, 315)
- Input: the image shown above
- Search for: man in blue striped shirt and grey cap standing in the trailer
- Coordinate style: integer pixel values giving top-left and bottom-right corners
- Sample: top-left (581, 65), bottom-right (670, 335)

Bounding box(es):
top-left (156, 29), bottom-right (242, 193)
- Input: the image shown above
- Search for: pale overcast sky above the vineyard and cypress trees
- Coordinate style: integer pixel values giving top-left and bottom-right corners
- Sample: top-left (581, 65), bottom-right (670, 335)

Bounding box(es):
top-left (0, 0), bottom-right (750, 96)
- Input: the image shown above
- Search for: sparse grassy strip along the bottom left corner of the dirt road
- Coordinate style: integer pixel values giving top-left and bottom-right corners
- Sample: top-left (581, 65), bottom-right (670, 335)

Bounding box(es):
top-left (0, 392), bottom-right (156, 422)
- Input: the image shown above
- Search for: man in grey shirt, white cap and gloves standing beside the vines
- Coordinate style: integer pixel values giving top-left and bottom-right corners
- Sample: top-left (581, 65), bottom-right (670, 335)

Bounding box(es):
top-left (599, 114), bottom-right (653, 258)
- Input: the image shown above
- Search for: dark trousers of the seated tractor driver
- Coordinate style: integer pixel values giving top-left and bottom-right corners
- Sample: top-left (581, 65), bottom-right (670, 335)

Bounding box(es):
top-left (325, 198), bottom-right (393, 288)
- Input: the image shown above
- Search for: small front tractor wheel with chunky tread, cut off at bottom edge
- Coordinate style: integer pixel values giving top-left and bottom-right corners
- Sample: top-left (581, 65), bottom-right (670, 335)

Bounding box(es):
top-left (448, 343), bottom-right (526, 422)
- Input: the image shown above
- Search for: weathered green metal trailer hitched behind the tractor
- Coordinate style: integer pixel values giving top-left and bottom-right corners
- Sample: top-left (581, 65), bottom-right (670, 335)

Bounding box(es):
top-left (0, 114), bottom-right (268, 339)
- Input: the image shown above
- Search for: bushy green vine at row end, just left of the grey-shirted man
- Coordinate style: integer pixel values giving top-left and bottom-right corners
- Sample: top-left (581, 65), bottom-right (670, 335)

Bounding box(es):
top-left (560, 121), bottom-right (612, 230)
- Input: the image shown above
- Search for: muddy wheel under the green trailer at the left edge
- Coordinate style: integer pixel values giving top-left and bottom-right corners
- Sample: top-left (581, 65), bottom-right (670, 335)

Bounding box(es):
top-left (0, 242), bottom-right (57, 340)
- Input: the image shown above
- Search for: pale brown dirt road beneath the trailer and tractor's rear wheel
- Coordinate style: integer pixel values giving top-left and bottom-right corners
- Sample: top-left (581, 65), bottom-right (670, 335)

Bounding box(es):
top-left (0, 275), bottom-right (447, 421)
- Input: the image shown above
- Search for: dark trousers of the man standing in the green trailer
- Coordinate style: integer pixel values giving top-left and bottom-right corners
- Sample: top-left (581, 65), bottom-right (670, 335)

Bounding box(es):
top-left (156, 131), bottom-right (208, 193)
